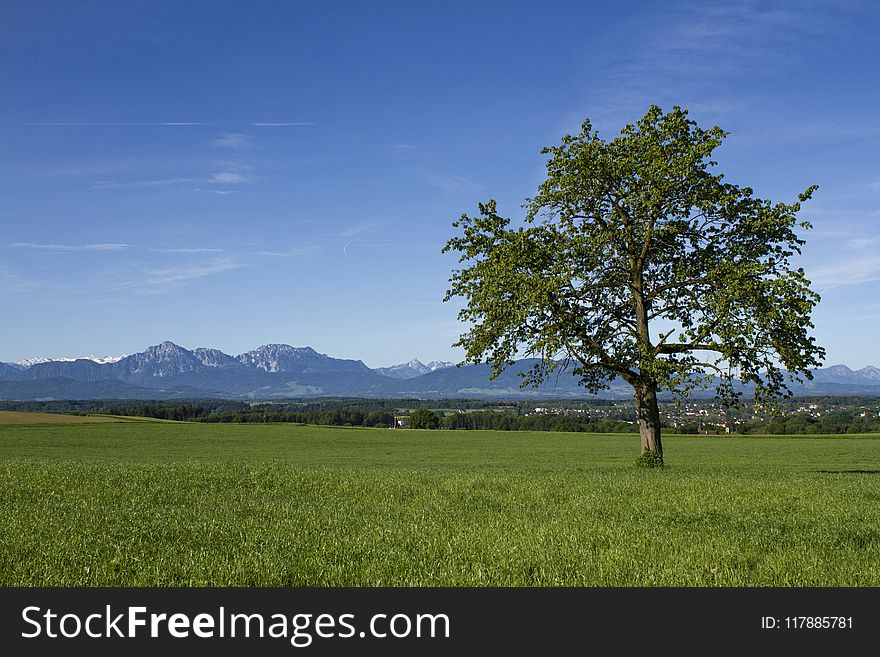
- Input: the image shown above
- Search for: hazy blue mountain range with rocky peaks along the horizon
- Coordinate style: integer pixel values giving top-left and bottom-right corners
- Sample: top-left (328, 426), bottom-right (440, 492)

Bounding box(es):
top-left (0, 342), bottom-right (880, 400)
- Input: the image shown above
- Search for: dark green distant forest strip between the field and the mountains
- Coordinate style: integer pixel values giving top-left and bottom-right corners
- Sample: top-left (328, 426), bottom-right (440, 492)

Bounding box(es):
top-left (0, 397), bottom-right (880, 435)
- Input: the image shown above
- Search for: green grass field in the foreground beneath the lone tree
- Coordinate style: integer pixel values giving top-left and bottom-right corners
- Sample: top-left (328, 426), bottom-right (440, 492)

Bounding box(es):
top-left (0, 412), bottom-right (880, 586)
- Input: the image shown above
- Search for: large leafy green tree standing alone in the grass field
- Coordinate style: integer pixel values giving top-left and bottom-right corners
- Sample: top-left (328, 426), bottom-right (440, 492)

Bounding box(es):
top-left (443, 106), bottom-right (824, 465)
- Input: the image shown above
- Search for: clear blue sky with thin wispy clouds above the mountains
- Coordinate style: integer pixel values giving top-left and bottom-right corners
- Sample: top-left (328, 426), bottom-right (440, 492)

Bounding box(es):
top-left (0, 0), bottom-right (880, 368)
